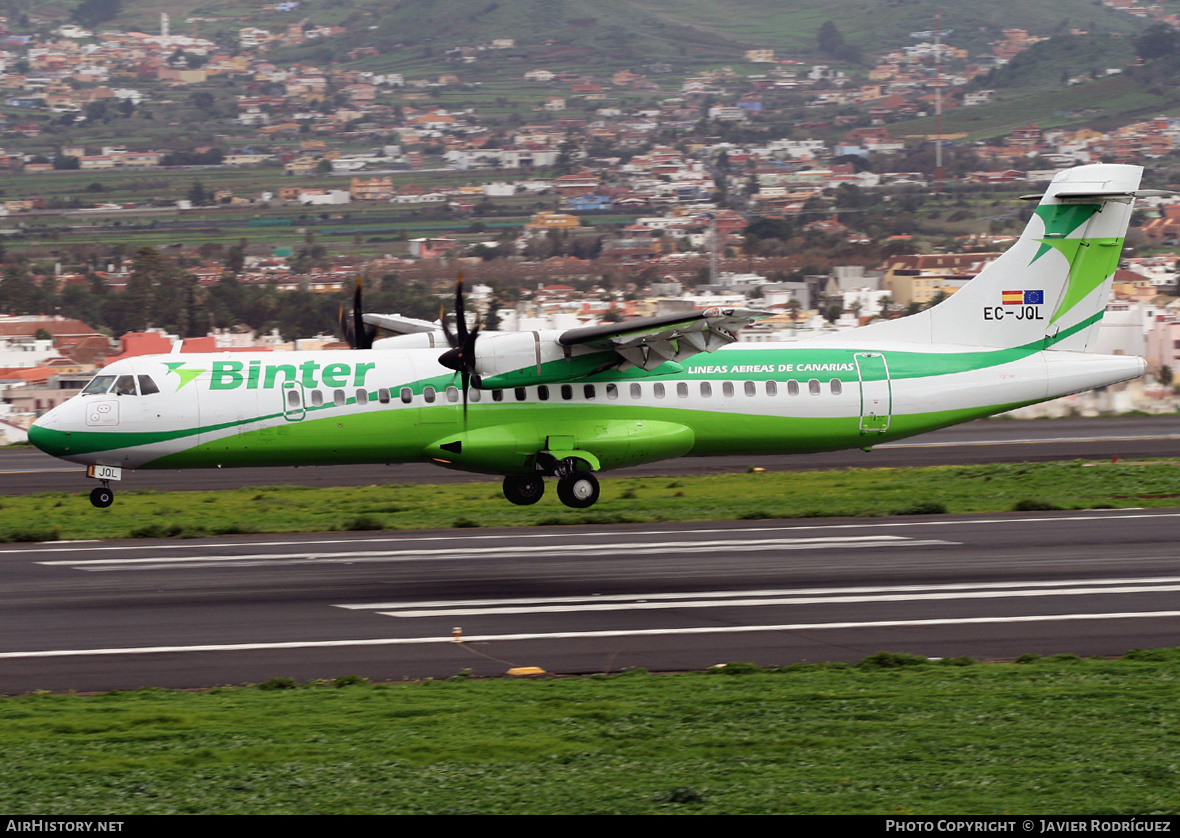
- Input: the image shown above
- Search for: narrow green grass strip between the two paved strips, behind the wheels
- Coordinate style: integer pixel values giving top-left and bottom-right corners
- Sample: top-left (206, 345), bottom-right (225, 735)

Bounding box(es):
top-left (0, 460), bottom-right (1180, 542)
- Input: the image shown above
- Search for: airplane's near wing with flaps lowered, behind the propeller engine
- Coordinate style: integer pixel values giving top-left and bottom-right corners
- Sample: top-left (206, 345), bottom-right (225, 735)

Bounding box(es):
top-left (557, 308), bottom-right (772, 371)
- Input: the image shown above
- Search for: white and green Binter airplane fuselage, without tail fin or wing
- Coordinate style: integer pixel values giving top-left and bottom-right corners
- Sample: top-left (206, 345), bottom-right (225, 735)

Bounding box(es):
top-left (31, 341), bottom-right (1143, 474)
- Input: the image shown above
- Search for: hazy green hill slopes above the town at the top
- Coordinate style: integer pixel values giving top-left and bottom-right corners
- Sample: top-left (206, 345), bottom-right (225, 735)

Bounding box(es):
top-left (16, 0), bottom-right (1161, 139)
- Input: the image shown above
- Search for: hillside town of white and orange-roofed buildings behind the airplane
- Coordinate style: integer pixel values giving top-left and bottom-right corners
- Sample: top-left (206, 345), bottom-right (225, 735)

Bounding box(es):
top-left (0, 0), bottom-right (1180, 441)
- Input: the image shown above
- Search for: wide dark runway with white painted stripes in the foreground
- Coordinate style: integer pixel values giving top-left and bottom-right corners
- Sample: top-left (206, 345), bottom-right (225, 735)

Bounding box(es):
top-left (0, 510), bottom-right (1180, 694)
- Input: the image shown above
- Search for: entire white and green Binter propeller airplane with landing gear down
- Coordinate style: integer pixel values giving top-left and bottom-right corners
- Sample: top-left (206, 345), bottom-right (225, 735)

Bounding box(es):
top-left (28, 164), bottom-right (1146, 508)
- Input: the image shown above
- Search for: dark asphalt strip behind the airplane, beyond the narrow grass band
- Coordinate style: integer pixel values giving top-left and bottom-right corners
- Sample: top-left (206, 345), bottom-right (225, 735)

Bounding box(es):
top-left (0, 415), bottom-right (1180, 495)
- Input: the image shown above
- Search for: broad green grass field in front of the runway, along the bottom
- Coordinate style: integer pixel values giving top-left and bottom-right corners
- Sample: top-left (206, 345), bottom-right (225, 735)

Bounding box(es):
top-left (0, 650), bottom-right (1180, 816)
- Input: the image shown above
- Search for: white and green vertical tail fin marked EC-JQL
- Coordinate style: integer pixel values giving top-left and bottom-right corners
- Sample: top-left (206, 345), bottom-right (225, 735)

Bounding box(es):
top-left (840, 164), bottom-right (1142, 352)
